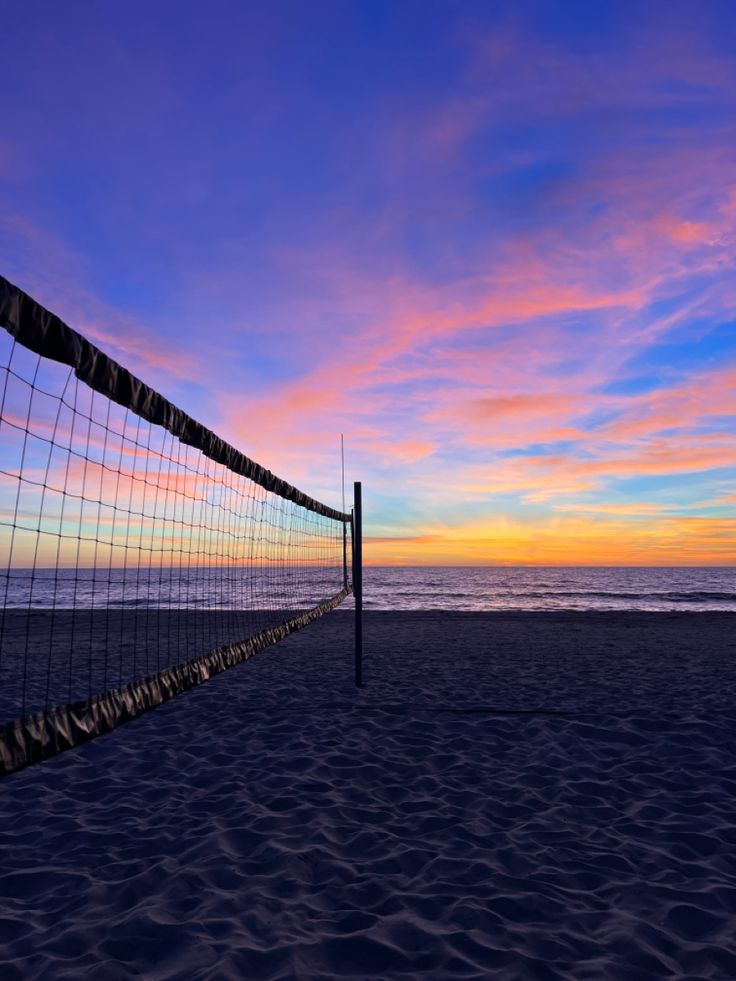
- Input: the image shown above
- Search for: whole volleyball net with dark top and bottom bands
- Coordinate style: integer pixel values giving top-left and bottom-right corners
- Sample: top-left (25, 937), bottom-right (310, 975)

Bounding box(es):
top-left (0, 277), bottom-right (352, 775)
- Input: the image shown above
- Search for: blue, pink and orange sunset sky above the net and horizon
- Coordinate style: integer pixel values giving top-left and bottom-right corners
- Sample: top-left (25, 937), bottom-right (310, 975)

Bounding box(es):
top-left (0, 0), bottom-right (736, 565)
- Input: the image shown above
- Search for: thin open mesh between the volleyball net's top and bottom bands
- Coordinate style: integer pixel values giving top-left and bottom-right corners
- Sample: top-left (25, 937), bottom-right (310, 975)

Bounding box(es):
top-left (0, 316), bottom-right (346, 723)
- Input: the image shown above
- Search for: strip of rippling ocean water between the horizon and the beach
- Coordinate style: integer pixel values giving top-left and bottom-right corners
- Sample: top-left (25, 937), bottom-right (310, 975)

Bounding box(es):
top-left (0, 566), bottom-right (736, 612)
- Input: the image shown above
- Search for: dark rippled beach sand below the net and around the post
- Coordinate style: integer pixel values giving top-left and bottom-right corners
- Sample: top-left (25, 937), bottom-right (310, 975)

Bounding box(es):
top-left (0, 612), bottom-right (736, 981)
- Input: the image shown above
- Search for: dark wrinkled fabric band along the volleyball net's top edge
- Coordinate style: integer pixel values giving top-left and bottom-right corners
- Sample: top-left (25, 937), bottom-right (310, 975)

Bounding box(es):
top-left (0, 276), bottom-right (351, 522)
